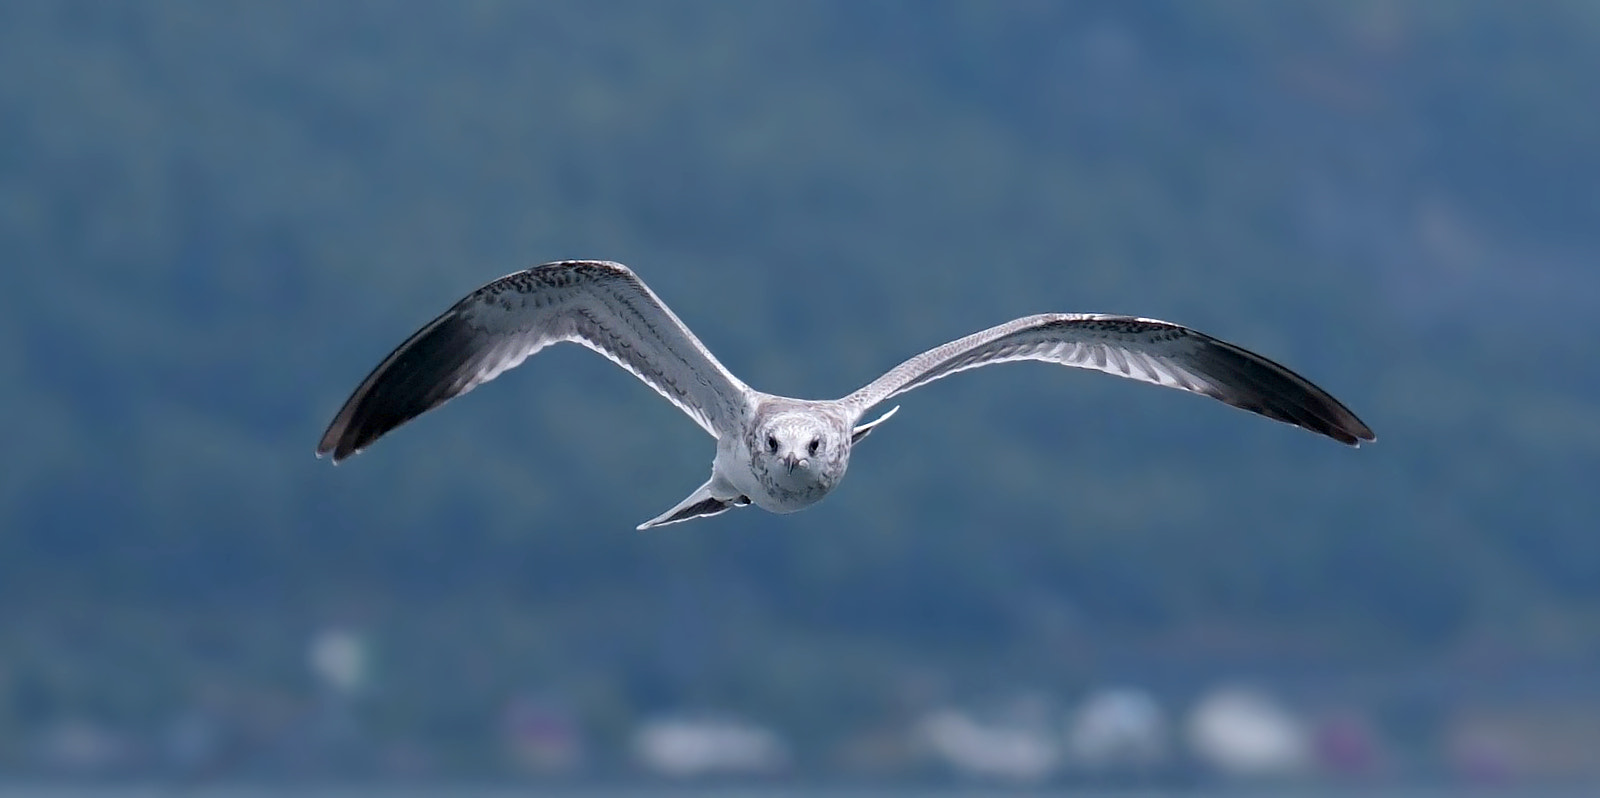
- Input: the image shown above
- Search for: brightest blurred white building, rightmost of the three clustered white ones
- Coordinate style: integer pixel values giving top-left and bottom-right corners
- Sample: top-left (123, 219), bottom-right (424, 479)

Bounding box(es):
top-left (1186, 688), bottom-right (1312, 779)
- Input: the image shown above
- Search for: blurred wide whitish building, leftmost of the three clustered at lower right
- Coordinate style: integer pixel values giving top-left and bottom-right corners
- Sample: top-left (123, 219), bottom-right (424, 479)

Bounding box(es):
top-left (912, 708), bottom-right (1061, 782)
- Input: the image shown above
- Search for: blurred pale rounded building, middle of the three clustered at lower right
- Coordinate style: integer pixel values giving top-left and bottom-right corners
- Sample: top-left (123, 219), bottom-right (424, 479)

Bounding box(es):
top-left (1066, 688), bottom-right (1171, 776)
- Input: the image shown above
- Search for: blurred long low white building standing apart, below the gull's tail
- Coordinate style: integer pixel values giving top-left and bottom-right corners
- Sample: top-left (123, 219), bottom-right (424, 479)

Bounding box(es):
top-left (634, 715), bottom-right (790, 779)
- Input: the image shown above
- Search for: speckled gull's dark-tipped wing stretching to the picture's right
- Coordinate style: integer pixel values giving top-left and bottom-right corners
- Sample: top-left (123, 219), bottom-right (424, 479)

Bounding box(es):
top-left (838, 313), bottom-right (1376, 446)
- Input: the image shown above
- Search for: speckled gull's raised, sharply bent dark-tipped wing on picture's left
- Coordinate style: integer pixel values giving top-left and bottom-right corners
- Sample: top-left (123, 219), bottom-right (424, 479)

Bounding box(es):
top-left (317, 261), bottom-right (750, 462)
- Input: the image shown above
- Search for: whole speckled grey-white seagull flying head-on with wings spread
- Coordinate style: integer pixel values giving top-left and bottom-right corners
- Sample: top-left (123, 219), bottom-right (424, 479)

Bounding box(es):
top-left (317, 261), bottom-right (1378, 529)
